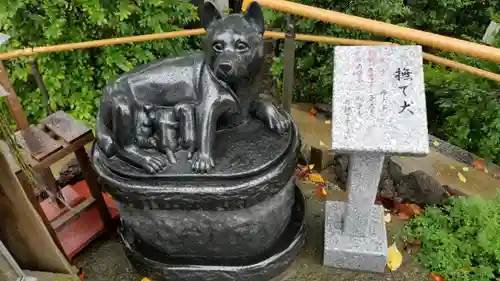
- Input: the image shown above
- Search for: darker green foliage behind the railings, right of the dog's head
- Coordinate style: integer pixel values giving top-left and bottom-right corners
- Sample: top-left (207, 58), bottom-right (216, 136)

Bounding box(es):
top-left (266, 0), bottom-right (500, 163)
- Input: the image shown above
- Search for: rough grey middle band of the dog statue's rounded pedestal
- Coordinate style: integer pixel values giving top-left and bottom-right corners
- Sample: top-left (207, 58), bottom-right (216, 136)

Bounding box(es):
top-left (120, 178), bottom-right (295, 259)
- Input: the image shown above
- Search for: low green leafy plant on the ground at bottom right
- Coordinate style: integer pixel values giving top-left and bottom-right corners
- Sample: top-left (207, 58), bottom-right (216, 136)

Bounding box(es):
top-left (404, 197), bottom-right (500, 281)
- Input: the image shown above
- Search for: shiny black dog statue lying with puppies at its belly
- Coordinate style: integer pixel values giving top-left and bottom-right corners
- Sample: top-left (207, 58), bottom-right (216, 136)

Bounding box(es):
top-left (96, 2), bottom-right (290, 174)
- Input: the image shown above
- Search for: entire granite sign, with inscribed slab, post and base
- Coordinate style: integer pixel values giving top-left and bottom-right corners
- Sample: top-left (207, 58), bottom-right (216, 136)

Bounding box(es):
top-left (324, 46), bottom-right (429, 272)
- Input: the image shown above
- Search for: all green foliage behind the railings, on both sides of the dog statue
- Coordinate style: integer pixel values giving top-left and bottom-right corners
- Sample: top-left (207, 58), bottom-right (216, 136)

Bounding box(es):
top-left (0, 0), bottom-right (500, 163)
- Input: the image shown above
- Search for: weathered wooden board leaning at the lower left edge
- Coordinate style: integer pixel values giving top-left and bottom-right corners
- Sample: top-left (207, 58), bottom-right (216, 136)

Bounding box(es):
top-left (0, 141), bottom-right (76, 274)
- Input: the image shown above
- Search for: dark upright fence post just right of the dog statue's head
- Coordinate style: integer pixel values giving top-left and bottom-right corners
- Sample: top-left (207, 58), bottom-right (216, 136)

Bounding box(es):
top-left (281, 14), bottom-right (295, 112)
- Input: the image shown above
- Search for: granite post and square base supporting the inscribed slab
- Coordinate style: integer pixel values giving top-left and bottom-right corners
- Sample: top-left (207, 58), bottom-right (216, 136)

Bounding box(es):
top-left (323, 153), bottom-right (387, 272)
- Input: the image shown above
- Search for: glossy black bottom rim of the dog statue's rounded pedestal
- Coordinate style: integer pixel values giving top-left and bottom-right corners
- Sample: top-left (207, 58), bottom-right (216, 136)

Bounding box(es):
top-left (120, 184), bottom-right (307, 281)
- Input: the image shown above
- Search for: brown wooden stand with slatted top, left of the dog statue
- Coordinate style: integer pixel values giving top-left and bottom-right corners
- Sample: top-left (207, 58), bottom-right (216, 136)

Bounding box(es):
top-left (0, 62), bottom-right (112, 259)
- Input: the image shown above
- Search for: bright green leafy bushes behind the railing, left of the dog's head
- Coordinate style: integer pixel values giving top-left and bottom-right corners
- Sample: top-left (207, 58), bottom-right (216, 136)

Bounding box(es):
top-left (0, 0), bottom-right (198, 126)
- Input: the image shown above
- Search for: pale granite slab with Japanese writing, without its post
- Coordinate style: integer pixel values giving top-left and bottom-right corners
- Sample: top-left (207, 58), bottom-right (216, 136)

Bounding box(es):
top-left (332, 46), bottom-right (429, 155)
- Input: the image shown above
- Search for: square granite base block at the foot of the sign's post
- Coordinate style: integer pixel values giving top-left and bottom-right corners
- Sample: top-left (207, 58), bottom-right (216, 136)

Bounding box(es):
top-left (323, 201), bottom-right (387, 273)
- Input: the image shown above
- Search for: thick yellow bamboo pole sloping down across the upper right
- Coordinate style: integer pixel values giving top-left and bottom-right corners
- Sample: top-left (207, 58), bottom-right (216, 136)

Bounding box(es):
top-left (243, 0), bottom-right (500, 63)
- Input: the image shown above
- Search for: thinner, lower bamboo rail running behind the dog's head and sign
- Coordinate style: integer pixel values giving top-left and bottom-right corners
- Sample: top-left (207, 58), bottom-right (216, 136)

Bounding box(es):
top-left (0, 29), bottom-right (500, 82)
